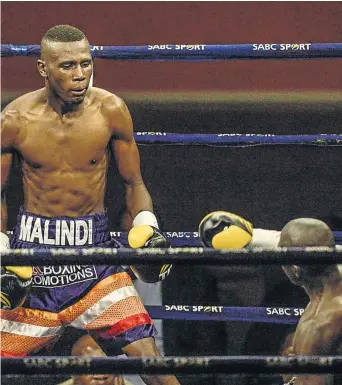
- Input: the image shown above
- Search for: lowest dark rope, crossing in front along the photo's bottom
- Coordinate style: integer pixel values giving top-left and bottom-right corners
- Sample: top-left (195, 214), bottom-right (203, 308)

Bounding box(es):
top-left (1, 356), bottom-right (342, 375)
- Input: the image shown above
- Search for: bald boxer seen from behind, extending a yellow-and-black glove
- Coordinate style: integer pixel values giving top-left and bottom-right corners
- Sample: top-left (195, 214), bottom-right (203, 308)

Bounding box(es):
top-left (198, 211), bottom-right (342, 385)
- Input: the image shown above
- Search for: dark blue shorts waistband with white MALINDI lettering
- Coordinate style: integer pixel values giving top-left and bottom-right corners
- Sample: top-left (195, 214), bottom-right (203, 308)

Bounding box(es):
top-left (13, 207), bottom-right (110, 247)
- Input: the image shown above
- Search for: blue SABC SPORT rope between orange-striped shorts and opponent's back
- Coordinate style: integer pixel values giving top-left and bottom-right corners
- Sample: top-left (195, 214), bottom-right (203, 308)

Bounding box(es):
top-left (145, 305), bottom-right (304, 325)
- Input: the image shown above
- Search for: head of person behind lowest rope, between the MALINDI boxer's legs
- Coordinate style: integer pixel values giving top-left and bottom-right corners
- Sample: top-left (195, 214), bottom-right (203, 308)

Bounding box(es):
top-left (71, 334), bottom-right (124, 385)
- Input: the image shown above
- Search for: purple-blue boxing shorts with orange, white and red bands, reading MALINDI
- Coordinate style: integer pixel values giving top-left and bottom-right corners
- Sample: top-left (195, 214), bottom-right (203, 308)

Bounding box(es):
top-left (0, 208), bottom-right (156, 356)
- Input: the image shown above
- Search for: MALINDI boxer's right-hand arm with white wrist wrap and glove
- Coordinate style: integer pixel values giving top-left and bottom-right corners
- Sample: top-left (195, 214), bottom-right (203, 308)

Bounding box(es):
top-left (106, 98), bottom-right (171, 282)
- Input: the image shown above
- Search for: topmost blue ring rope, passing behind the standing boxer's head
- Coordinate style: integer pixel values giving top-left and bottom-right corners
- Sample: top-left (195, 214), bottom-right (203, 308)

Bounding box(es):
top-left (1, 43), bottom-right (342, 61)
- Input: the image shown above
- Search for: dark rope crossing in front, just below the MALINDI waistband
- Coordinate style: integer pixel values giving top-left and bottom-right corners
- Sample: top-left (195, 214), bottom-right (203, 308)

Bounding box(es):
top-left (1, 247), bottom-right (342, 266)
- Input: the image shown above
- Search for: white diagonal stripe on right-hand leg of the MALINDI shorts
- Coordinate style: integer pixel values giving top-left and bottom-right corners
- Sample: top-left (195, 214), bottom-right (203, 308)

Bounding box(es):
top-left (70, 286), bottom-right (139, 329)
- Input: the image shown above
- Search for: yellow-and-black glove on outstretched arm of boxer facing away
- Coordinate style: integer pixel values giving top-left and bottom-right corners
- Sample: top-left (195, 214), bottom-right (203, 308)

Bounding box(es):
top-left (198, 211), bottom-right (253, 249)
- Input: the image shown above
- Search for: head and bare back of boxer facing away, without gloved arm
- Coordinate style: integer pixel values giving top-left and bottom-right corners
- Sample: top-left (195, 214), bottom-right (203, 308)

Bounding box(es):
top-left (279, 218), bottom-right (342, 385)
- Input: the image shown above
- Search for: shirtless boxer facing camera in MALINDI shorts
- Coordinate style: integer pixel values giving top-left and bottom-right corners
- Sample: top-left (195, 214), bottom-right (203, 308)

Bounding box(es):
top-left (0, 25), bottom-right (179, 384)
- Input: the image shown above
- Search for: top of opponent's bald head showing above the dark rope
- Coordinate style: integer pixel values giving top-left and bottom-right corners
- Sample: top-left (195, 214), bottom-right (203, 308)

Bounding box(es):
top-left (279, 218), bottom-right (335, 247)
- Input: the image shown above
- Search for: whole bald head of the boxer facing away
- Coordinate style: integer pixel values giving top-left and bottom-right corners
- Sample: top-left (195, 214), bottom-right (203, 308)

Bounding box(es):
top-left (279, 218), bottom-right (335, 286)
